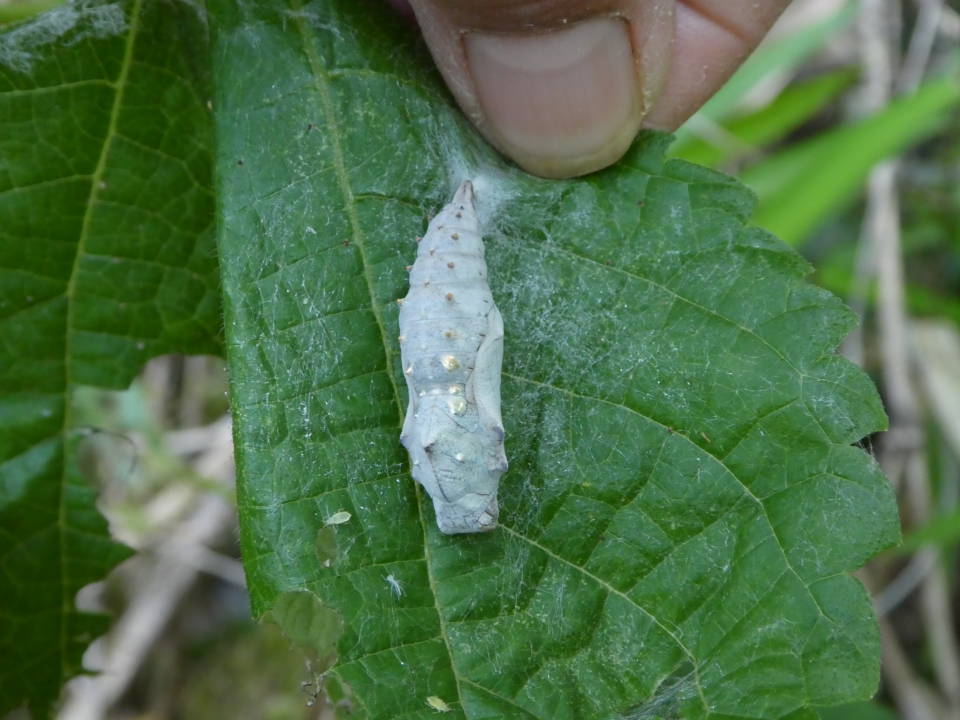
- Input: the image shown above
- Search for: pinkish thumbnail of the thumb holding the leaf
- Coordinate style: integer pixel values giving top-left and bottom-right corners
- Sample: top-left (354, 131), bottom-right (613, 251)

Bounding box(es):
top-left (464, 17), bottom-right (643, 178)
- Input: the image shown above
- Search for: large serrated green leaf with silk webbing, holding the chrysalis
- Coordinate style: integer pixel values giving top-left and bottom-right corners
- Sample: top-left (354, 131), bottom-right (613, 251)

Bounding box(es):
top-left (210, 0), bottom-right (898, 720)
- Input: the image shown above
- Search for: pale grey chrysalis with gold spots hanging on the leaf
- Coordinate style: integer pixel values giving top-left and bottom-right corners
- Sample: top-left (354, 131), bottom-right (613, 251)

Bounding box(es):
top-left (400, 181), bottom-right (507, 534)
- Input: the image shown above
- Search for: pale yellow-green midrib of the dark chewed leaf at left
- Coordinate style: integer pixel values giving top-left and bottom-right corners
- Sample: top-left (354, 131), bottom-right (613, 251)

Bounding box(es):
top-left (57, 0), bottom-right (142, 676)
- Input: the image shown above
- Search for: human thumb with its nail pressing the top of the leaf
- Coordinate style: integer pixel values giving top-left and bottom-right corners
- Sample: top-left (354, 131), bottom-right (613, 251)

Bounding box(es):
top-left (410, 0), bottom-right (674, 178)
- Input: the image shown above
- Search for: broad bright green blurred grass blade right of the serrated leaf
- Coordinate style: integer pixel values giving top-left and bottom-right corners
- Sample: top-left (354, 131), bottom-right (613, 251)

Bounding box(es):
top-left (742, 75), bottom-right (960, 244)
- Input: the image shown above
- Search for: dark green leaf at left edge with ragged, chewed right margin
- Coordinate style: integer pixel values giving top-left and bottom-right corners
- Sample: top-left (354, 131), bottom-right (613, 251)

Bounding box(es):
top-left (0, 0), bottom-right (220, 717)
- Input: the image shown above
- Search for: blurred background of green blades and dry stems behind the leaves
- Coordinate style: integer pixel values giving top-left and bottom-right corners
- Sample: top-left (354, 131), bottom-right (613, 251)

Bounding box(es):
top-left (0, 0), bottom-right (960, 720)
